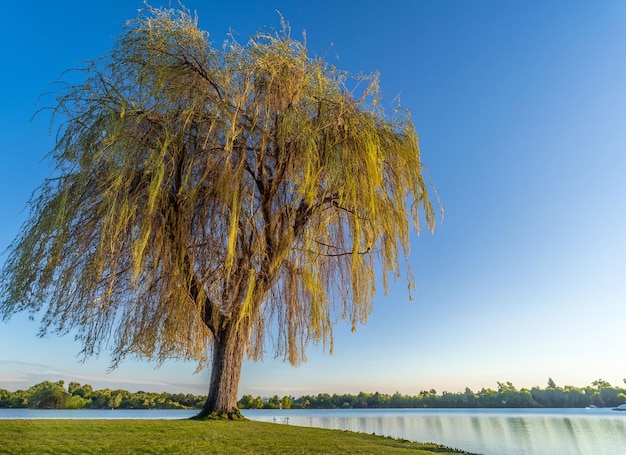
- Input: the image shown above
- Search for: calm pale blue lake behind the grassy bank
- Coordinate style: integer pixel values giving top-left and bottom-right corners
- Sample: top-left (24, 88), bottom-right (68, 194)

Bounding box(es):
top-left (0, 408), bottom-right (626, 455)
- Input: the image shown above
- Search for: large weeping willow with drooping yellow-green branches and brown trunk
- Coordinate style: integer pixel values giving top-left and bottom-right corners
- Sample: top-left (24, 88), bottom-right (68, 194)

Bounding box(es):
top-left (0, 8), bottom-right (434, 417)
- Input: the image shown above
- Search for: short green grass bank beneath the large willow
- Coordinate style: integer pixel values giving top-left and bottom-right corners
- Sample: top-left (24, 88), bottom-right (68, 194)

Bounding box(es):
top-left (0, 419), bottom-right (478, 455)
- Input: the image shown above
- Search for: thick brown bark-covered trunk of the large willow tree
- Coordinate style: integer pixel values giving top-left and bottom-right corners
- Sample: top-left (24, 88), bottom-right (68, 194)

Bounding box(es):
top-left (194, 321), bottom-right (249, 420)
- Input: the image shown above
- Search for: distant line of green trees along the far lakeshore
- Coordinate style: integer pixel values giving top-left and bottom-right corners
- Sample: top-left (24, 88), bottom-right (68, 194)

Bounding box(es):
top-left (0, 379), bottom-right (626, 409)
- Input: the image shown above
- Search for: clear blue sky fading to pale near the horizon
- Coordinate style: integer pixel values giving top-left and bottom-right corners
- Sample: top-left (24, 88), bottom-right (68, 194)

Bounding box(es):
top-left (0, 0), bottom-right (626, 396)
